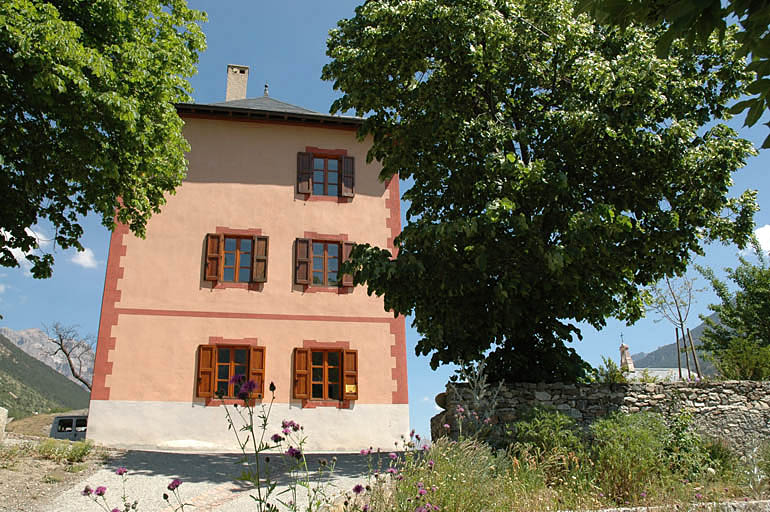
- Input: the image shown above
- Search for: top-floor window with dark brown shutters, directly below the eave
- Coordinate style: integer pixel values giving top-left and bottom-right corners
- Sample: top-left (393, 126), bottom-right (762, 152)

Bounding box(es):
top-left (297, 152), bottom-right (355, 197)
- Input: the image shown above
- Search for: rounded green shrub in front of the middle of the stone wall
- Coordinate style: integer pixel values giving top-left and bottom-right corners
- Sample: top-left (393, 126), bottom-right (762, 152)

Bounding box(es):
top-left (591, 412), bottom-right (667, 502)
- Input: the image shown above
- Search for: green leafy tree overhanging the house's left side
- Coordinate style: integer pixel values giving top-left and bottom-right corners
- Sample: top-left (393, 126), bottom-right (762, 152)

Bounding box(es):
top-left (0, 0), bottom-right (205, 278)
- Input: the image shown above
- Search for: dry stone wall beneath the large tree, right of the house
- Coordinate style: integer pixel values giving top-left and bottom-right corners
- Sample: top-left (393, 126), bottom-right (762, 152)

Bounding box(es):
top-left (431, 381), bottom-right (770, 452)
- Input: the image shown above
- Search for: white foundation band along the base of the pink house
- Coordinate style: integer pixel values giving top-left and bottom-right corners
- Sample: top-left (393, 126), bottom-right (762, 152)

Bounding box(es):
top-left (87, 400), bottom-right (409, 452)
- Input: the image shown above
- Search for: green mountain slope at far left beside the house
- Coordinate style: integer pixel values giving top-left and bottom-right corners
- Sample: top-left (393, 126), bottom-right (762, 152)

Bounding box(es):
top-left (0, 335), bottom-right (89, 418)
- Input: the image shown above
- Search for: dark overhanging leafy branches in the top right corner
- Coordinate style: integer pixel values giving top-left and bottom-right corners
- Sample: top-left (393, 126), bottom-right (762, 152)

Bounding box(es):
top-left (581, 0), bottom-right (770, 148)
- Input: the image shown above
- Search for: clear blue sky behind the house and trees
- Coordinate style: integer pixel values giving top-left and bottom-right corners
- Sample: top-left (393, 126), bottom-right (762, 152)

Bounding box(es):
top-left (0, 0), bottom-right (770, 440)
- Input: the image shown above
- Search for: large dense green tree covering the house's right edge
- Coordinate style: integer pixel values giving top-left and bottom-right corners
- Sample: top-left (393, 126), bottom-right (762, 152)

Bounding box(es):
top-left (323, 0), bottom-right (756, 381)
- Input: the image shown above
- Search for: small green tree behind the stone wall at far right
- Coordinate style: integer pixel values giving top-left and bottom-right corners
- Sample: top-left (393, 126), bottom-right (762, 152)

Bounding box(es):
top-left (698, 240), bottom-right (770, 380)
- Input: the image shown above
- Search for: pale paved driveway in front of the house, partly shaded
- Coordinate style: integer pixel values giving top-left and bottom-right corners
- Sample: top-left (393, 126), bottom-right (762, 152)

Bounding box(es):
top-left (42, 451), bottom-right (380, 512)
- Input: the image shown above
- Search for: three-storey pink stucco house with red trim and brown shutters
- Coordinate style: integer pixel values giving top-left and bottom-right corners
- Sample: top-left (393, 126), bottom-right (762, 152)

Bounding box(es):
top-left (88, 66), bottom-right (409, 451)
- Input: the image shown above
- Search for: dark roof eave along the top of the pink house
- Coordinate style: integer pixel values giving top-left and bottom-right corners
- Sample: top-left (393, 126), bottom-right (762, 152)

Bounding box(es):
top-left (174, 103), bottom-right (364, 128)
